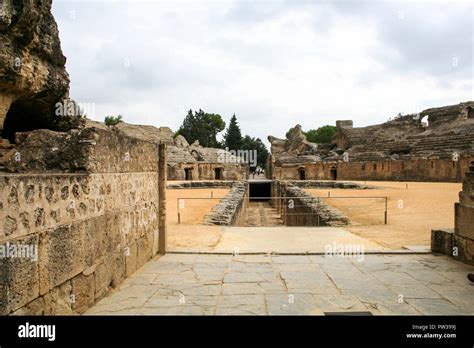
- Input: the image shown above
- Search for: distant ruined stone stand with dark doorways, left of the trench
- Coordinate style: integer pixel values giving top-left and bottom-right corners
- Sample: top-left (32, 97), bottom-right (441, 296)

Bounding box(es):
top-left (168, 135), bottom-right (249, 180)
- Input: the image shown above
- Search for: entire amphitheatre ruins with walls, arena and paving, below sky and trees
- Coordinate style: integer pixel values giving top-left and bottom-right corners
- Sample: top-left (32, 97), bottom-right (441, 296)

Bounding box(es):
top-left (0, 0), bottom-right (474, 315)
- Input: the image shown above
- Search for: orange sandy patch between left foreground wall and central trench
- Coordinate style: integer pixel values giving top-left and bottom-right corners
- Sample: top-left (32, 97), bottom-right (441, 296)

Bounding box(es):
top-left (166, 188), bottom-right (229, 250)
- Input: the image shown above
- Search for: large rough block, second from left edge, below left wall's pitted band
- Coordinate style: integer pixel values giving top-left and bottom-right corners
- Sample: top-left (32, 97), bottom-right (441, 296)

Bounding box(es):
top-left (39, 222), bottom-right (85, 295)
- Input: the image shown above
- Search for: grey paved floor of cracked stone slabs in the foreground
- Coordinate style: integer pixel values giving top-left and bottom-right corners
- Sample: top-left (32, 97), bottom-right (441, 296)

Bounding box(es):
top-left (86, 254), bottom-right (474, 315)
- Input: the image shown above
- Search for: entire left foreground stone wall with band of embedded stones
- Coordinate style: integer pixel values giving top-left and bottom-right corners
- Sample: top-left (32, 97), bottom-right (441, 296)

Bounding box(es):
top-left (0, 128), bottom-right (158, 315)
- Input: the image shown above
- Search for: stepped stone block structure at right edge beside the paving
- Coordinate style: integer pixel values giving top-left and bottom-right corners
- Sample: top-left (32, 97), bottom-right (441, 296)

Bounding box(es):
top-left (431, 162), bottom-right (474, 265)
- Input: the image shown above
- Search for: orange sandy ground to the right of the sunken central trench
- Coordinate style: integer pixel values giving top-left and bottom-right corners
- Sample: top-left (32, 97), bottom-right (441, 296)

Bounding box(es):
top-left (307, 181), bottom-right (461, 249)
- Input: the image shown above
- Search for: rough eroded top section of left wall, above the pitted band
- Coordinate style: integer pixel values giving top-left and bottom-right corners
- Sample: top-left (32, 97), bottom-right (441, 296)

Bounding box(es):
top-left (5, 127), bottom-right (157, 173)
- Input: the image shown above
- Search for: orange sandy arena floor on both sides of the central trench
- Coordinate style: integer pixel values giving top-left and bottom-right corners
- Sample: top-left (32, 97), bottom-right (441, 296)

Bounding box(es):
top-left (167, 181), bottom-right (461, 250)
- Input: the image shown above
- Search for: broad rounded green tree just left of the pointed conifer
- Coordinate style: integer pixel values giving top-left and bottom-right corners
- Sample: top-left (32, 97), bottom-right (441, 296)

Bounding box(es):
top-left (176, 109), bottom-right (225, 147)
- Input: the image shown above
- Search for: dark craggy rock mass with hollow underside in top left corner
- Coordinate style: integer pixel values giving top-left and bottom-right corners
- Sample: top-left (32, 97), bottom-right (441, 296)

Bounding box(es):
top-left (0, 0), bottom-right (69, 140)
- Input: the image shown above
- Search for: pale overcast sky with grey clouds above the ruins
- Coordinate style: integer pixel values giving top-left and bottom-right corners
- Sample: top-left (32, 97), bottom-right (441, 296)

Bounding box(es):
top-left (53, 0), bottom-right (474, 143)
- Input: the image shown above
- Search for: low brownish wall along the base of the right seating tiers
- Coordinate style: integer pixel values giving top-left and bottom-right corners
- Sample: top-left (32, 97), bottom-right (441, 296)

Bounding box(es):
top-left (271, 157), bottom-right (470, 182)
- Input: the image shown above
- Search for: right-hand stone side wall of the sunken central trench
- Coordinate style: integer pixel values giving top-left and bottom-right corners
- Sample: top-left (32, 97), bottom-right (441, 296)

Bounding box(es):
top-left (272, 181), bottom-right (349, 226)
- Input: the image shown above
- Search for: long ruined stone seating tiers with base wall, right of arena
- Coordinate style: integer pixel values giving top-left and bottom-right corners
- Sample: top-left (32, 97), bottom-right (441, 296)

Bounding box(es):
top-left (267, 102), bottom-right (474, 182)
